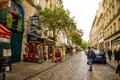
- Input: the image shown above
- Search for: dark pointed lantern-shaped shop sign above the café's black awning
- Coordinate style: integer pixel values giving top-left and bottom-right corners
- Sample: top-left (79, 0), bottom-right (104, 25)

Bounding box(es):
top-left (27, 14), bottom-right (44, 43)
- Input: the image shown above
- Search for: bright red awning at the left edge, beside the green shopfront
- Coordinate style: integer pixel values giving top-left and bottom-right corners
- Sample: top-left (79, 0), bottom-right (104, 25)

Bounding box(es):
top-left (0, 24), bottom-right (12, 38)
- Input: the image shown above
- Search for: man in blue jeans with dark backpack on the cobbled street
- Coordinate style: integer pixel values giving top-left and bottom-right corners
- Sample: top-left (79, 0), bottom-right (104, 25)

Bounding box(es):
top-left (86, 47), bottom-right (96, 71)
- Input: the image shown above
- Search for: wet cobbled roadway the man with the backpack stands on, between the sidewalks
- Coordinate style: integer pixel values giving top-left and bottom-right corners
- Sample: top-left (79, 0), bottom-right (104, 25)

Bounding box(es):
top-left (27, 52), bottom-right (120, 80)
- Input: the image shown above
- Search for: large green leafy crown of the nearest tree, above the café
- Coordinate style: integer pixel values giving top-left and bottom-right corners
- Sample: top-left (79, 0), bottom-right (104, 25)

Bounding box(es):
top-left (39, 7), bottom-right (75, 39)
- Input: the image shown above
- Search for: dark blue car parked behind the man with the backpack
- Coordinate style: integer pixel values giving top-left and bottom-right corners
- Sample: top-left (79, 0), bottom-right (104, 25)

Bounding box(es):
top-left (93, 49), bottom-right (106, 64)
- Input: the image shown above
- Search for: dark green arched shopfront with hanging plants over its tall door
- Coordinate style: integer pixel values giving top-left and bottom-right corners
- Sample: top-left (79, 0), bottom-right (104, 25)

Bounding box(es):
top-left (0, 0), bottom-right (24, 63)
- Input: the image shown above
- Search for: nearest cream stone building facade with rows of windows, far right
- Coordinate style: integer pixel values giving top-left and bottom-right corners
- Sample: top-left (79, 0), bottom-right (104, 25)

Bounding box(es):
top-left (102, 0), bottom-right (120, 50)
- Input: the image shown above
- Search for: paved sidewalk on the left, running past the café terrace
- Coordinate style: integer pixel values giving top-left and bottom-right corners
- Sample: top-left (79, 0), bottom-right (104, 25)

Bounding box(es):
top-left (0, 52), bottom-right (73, 80)
